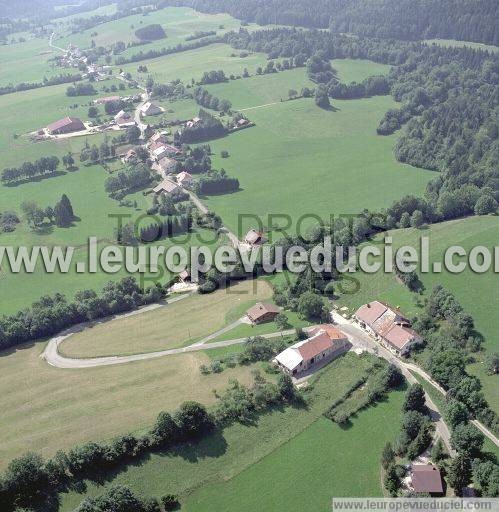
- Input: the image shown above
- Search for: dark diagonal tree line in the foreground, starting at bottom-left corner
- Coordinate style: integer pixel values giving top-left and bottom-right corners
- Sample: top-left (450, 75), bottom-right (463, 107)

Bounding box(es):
top-left (0, 371), bottom-right (302, 512)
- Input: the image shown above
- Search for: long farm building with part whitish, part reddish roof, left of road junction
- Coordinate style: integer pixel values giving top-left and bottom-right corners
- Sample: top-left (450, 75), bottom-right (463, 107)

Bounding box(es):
top-left (274, 325), bottom-right (350, 376)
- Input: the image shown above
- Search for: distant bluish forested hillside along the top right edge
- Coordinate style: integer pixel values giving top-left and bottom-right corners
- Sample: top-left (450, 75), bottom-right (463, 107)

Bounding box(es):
top-left (159, 0), bottom-right (499, 45)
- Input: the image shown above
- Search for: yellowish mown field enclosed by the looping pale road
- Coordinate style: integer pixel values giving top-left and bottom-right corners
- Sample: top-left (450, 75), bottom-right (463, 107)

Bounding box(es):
top-left (60, 280), bottom-right (272, 357)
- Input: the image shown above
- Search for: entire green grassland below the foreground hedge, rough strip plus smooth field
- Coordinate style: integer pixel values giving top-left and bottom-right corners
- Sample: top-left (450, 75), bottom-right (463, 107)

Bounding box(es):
top-left (61, 354), bottom-right (403, 512)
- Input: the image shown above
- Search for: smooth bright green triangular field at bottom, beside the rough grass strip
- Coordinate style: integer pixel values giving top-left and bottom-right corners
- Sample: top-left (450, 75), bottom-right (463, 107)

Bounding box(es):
top-left (185, 392), bottom-right (402, 512)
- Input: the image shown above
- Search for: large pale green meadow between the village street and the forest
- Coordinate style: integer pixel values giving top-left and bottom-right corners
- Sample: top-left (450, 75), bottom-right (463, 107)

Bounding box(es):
top-left (201, 63), bottom-right (435, 234)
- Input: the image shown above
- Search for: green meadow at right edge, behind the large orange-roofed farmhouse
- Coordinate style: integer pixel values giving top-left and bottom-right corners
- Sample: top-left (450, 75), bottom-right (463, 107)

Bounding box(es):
top-left (339, 216), bottom-right (499, 411)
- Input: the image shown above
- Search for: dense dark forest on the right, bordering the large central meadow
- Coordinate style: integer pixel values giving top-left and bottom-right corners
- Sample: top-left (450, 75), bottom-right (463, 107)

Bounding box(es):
top-left (225, 28), bottom-right (499, 223)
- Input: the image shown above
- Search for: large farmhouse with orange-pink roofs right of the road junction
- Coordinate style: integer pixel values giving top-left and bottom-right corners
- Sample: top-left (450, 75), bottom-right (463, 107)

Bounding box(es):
top-left (354, 301), bottom-right (422, 355)
